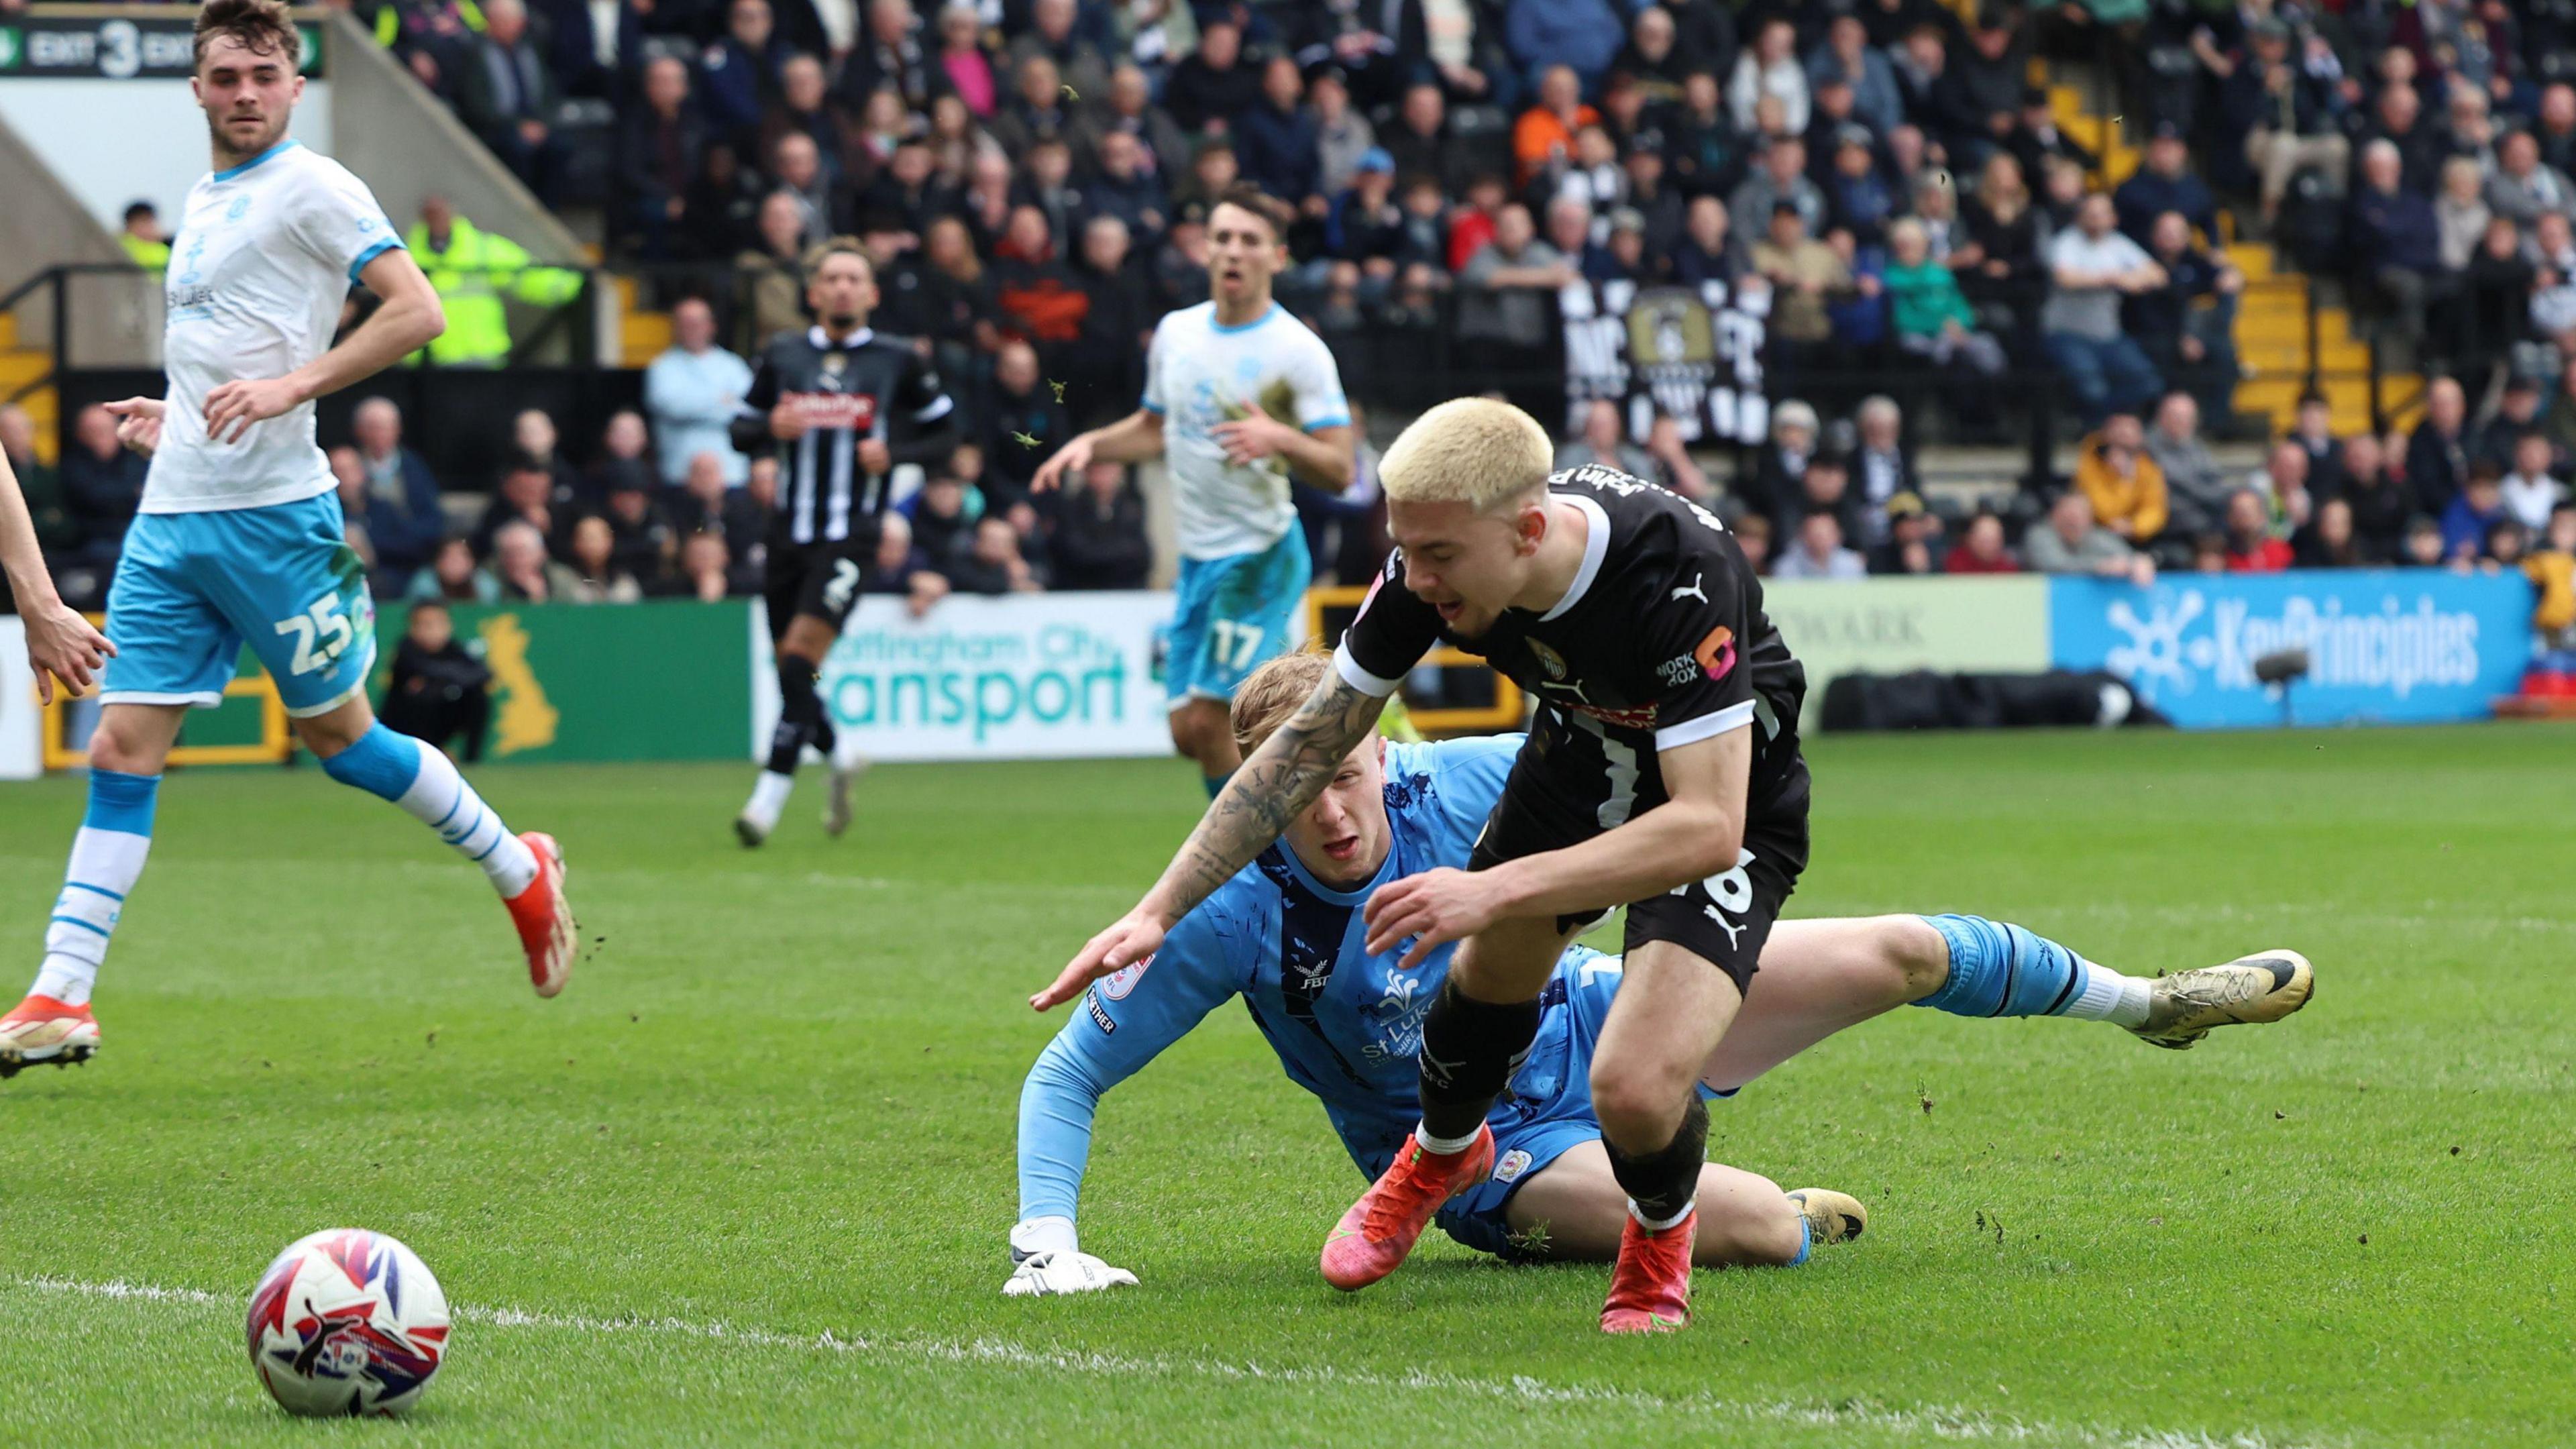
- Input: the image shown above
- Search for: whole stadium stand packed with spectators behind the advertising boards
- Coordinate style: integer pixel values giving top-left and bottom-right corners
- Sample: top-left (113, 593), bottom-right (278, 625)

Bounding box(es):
top-left (0, 0), bottom-right (2576, 665)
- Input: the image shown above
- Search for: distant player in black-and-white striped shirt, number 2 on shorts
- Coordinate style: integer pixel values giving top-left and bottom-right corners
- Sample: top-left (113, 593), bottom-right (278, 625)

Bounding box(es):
top-left (732, 237), bottom-right (956, 846)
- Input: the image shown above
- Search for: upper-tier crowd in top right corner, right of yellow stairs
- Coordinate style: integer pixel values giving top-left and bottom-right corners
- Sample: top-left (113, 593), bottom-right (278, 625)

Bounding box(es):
top-left (2120, 0), bottom-right (2576, 376)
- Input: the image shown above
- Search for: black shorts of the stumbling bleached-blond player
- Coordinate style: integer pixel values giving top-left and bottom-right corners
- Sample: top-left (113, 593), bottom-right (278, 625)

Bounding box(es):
top-left (1466, 724), bottom-right (1809, 993)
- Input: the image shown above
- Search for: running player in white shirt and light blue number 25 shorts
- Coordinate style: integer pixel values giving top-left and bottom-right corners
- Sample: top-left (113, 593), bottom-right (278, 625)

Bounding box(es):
top-left (0, 0), bottom-right (574, 1073)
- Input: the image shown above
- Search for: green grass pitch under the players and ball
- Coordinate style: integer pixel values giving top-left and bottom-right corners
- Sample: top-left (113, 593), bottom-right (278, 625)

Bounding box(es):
top-left (0, 727), bottom-right (2576, 1449)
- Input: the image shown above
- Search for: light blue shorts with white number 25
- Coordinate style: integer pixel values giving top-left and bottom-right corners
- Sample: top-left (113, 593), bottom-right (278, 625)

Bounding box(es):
top-left (101, 492), bottom-right (376, 719)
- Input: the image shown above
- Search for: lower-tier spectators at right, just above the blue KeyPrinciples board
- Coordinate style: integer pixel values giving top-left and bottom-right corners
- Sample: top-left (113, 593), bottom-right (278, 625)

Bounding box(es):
top-left (1710, 369), bottom-right (2576, 603)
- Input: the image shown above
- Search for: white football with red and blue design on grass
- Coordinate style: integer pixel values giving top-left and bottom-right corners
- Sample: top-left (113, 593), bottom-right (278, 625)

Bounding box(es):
top-left (250, 1227), bottom-right (448, 1418)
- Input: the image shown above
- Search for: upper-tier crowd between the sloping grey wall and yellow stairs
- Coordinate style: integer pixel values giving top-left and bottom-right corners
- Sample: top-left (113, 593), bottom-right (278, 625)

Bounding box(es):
top-left (342, 0), bottom-right (2313, 423)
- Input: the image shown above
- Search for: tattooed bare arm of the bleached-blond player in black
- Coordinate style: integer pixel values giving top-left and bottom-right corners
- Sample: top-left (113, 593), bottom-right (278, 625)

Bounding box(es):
top-left (1028, 673), bottom-right (1386, 1011)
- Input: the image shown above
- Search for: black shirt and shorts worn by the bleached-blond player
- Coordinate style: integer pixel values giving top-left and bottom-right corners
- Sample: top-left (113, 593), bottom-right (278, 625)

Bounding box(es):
top-left (1337, 464), bottom-right (1809, 990)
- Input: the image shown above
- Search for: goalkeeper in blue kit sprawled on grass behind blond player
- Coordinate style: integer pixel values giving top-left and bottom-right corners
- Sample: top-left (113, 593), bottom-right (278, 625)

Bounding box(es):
top-left (1005, 655), bottom-right (2303, 1297)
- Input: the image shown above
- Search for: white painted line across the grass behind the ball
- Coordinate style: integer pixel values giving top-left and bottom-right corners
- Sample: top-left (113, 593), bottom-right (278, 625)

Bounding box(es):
top-left (15, 1279), bottom-right (2349, 1449)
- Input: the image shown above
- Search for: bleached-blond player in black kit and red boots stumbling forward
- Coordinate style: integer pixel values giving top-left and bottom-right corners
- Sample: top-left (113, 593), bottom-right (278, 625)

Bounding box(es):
top-left (1051, 400), bottom-right (2308, 1333)
